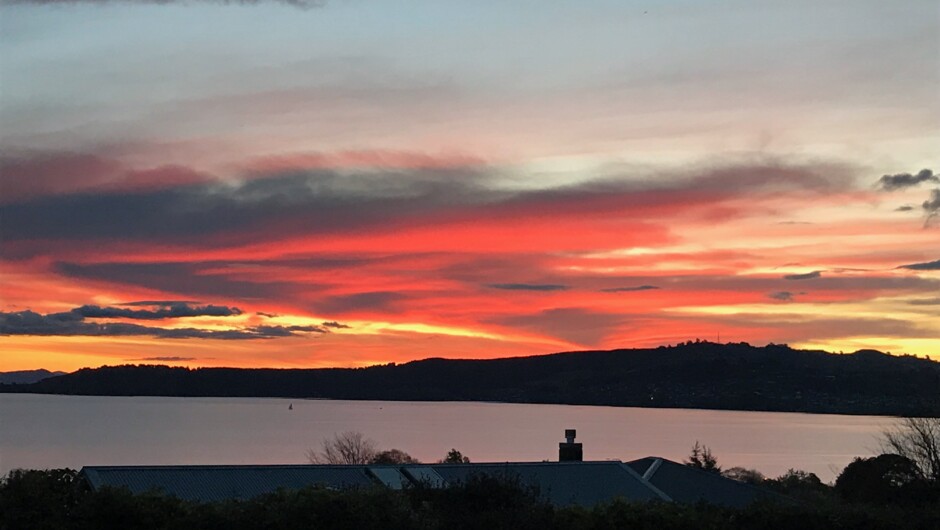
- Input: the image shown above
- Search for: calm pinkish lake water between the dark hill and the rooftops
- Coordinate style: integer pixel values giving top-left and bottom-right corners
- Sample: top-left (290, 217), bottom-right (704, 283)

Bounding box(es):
top-left (0, 394), bottom-right (894, 481)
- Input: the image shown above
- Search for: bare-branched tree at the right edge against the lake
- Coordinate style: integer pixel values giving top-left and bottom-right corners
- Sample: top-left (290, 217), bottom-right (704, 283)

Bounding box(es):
top-left (882, 418), bottom-right (940, 483)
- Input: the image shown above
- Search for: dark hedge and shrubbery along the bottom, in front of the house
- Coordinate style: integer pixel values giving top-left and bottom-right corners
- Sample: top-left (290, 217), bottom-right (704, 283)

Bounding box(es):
top-left (0, 470), bottom-right (940, 530)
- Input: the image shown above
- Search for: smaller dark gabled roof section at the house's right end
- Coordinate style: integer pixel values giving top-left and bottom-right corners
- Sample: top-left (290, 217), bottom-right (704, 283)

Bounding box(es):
top-left (626, 456), bottom-right (790, 507)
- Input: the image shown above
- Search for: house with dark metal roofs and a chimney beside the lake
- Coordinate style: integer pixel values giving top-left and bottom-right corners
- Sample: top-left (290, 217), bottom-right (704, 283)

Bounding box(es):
top-left (81, 430), bottom-right (782, 506)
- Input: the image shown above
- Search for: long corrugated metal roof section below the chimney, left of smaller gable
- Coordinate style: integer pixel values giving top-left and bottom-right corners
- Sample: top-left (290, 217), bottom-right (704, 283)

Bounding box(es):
top-left (82, 461), bottom-right (669, 506)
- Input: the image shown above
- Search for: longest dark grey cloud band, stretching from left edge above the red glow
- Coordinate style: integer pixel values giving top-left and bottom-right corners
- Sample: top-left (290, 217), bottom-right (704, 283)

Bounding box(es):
top-left (0, 154), bottom-right (846, 258)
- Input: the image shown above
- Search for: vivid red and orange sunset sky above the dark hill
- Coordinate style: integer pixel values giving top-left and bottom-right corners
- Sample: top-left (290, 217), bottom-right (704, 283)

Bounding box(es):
top-left (0, 0), bottom-right (940, 371)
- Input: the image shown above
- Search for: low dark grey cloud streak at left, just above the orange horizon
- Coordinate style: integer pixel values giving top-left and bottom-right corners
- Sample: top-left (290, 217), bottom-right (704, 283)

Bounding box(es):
top-left (0, 310), bottom-right (328, 340)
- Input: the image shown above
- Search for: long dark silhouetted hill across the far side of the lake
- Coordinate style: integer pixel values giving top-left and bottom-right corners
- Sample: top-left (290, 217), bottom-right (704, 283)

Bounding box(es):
top-left (0, 342), bottom-right (940, 416)
